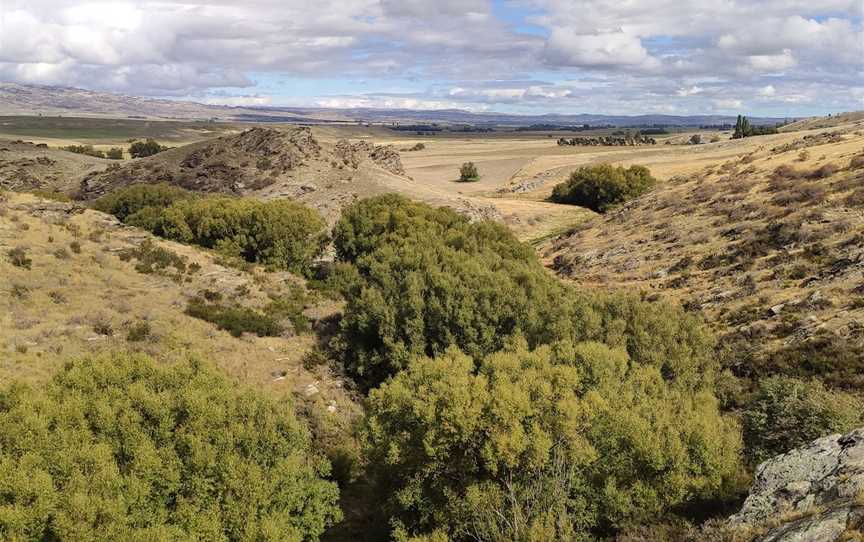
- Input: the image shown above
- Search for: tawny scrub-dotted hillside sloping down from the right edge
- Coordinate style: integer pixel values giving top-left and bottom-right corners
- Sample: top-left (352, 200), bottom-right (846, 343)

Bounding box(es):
top-left (544, 126), bottom-right (864, 387)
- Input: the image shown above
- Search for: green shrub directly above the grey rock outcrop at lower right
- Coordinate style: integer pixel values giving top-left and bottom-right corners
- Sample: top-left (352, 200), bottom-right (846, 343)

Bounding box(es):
top-left (744, 376), bottom-right (864, 464)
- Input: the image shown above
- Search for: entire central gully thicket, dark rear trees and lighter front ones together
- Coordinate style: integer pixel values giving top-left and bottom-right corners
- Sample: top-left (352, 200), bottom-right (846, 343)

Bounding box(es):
top-left (331, 195), bottom-right (741, 541)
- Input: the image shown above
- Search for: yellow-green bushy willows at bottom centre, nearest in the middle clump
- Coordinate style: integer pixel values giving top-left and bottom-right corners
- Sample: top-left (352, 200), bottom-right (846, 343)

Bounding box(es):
top-left (365, 343), bottom-right (740, 542)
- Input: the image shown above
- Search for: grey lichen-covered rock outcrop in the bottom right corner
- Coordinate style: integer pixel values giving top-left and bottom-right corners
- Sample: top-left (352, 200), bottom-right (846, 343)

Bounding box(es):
top-left (729, 428), bottom-right (864, 542)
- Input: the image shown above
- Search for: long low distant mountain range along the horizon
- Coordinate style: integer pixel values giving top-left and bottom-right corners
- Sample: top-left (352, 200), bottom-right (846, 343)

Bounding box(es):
top-left (0, 83), bottom-right (784, 127)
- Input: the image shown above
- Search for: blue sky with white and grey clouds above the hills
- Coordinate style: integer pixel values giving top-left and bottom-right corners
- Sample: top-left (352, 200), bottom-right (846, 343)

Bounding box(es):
top-left (0, 0), bottom-right (864, 116)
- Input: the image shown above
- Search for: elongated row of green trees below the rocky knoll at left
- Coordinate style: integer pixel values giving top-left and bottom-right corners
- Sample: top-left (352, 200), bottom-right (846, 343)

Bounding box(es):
top-left (95, 185), bottom-right (326, 273)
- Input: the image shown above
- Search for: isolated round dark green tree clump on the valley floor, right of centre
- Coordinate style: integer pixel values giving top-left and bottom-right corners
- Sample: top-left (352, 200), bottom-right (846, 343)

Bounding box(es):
top-left (552, 164), bottom-right (657, 213)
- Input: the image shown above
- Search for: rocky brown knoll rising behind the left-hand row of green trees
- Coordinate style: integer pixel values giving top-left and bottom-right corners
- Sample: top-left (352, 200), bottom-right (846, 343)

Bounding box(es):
top-left (78, 127), bottom-right (409, 219)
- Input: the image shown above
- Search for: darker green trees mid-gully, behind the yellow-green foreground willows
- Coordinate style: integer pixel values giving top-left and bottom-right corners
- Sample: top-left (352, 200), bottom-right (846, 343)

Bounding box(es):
top-left (334, 196), bottom-right (712, 387)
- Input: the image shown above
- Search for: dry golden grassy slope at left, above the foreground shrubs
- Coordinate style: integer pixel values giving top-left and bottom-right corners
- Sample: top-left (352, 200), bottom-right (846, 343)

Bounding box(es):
top-left (0, 192), bottom-right (352, 411)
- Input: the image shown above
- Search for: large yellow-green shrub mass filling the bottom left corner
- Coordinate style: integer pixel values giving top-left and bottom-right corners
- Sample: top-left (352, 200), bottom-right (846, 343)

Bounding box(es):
top-left (0, 355), bottom-right (340, 542)
